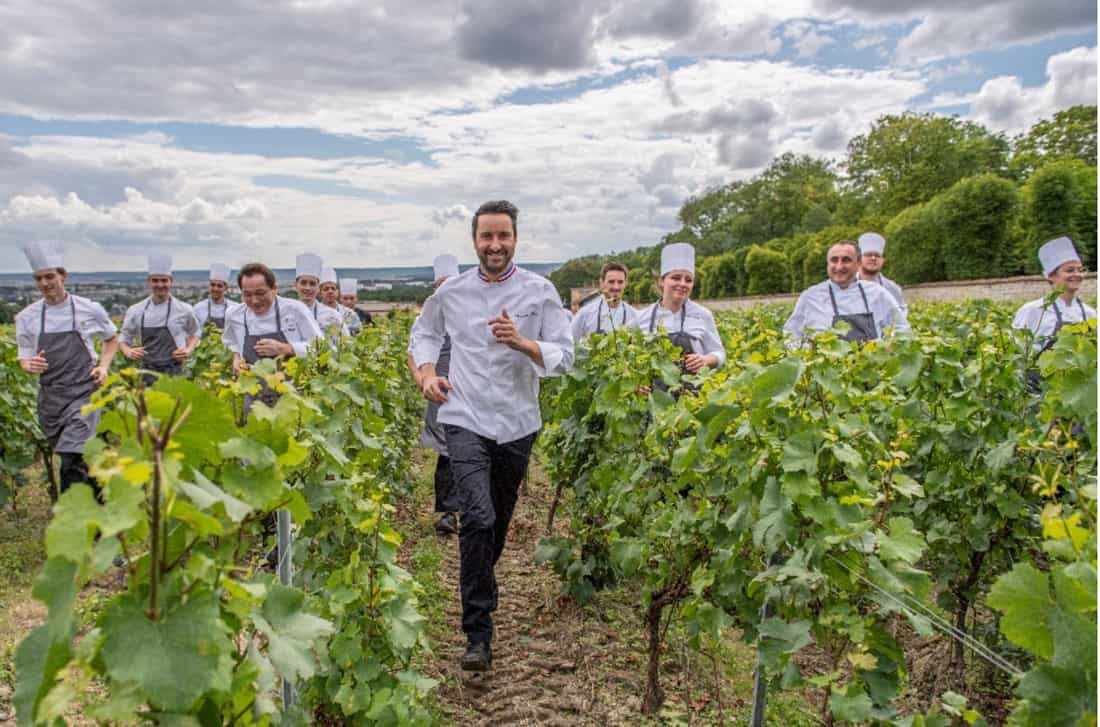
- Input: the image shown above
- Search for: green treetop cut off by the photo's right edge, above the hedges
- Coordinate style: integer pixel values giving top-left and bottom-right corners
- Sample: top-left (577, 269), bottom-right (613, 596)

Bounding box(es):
top-left (1011, 106), bottom-right (1097, 179)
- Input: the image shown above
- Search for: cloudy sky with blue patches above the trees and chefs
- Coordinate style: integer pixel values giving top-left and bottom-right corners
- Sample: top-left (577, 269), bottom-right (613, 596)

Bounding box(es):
top-left (0, 0), bottom-right (1097, 272)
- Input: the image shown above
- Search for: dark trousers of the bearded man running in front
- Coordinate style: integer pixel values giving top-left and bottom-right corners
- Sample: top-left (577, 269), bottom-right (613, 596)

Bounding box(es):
top-left (444, 425), bottom-right (537, 643)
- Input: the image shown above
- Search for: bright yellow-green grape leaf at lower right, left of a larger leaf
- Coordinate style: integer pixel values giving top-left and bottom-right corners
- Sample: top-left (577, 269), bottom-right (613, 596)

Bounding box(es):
top-left (987, 563), bottom-right (1054, 659)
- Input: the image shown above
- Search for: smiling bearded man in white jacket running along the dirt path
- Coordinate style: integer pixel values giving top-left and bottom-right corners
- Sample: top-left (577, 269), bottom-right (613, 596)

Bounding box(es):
top-left (409, 200), bottom-right (573, 671)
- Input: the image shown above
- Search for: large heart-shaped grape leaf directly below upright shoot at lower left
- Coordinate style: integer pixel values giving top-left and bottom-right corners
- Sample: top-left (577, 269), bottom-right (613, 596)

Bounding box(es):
top-left (100, 593), bottom-right (232, 712)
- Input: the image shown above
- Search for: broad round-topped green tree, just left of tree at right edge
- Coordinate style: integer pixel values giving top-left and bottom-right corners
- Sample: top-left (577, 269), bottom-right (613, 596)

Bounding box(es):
top-left (845, 112), bottom-right (1009, 216)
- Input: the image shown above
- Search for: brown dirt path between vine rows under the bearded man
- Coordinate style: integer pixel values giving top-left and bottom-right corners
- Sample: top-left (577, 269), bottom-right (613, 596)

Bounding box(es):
top-left (413, 456), bottom-right (642, 727)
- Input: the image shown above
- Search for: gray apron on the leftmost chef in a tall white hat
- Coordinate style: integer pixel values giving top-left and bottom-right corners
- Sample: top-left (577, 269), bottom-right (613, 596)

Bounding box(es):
top-left (37, 296), bottom-right (100, 454)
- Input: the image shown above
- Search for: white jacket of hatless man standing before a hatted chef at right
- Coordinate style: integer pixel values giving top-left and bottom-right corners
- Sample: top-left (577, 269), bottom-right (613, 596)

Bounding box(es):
top-left (783, 280), bottom-right (912, 340)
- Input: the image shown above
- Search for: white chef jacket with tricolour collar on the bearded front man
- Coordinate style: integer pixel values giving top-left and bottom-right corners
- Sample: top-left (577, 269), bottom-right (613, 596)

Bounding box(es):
top-left (409, 265), bottom-right (573, 444)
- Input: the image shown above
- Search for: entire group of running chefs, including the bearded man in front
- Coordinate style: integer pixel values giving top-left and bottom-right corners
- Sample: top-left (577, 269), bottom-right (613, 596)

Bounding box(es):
top-left (15, 200), bottom-right (1097, 671)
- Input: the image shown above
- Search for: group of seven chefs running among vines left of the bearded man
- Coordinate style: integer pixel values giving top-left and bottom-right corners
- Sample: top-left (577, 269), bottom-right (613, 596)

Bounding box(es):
top-left (15, 241), bottom-right (370, 492)
